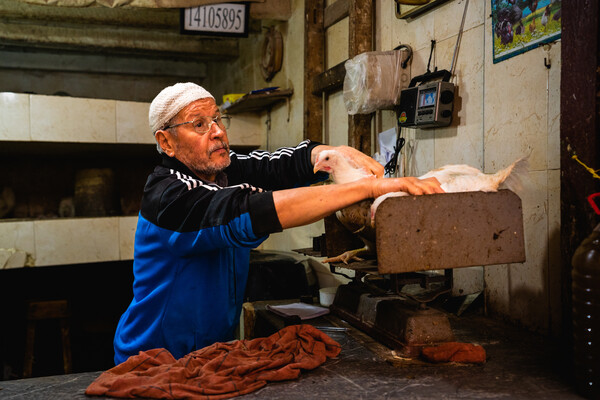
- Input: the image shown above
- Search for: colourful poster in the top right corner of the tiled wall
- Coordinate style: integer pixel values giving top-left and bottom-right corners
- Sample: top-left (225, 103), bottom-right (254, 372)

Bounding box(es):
top-left (491, 0), bottom-right (561, 64)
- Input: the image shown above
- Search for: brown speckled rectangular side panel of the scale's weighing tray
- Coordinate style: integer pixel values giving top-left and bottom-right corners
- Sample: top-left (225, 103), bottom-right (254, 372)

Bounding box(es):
top-left (375, 190), bottom-right (525, 274)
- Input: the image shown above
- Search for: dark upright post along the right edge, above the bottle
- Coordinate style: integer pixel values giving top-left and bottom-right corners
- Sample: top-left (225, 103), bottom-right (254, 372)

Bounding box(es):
top-left (560, 0), bottom-right (600, 346)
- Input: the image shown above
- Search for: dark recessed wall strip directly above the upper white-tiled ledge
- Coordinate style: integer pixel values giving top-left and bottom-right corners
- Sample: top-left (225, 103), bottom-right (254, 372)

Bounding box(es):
top-left (0, 49), bottom-right (206, 102)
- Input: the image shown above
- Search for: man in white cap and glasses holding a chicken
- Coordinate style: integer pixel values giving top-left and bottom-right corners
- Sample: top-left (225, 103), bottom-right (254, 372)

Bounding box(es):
top-left (114, 82), bottom-right (442, 364)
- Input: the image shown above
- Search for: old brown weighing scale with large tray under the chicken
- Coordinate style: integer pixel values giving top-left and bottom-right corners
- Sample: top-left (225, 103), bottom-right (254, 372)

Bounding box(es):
top-left (318, 190), bottom-right (525, 357)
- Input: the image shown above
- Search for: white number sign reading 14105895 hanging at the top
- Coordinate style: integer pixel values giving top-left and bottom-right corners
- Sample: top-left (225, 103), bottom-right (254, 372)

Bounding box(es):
top-left (181, 3), bottom-right (248, 36)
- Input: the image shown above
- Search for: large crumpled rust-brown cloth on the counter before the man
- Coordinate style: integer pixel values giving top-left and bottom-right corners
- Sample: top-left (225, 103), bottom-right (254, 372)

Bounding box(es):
top-left (85, 325), bottom-right (341, 400)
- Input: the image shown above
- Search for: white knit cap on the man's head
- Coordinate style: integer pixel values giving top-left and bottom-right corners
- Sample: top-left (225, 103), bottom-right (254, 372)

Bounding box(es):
top-left (148, 82), bottom-right (215, 134)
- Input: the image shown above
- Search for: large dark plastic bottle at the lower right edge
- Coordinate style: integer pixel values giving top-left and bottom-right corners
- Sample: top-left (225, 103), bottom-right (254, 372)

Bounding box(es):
top-left (572, 224), bottom-right (600, 399)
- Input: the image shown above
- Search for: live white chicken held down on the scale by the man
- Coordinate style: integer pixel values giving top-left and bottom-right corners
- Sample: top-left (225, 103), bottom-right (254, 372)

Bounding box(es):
top-left (314, 150), bottom-right (528, 263)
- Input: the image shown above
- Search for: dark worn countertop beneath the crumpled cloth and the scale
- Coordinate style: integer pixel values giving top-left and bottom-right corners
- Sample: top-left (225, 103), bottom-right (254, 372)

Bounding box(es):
top-left (0, 314), bottom-right (582, 400)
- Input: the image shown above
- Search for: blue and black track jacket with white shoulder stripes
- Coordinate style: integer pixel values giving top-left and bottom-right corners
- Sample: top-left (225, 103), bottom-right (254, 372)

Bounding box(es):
top-left (114, 141), bottom-right (327, 364)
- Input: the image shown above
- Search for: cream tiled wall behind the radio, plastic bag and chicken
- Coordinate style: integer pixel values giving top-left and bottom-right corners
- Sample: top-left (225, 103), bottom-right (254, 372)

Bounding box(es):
top-left (220, 0), bottom-right (561, 333)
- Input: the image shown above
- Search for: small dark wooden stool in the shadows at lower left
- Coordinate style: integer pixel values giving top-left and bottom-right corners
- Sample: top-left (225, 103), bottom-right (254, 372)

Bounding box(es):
top-left (23, 300), bottom-right (72, 378)
